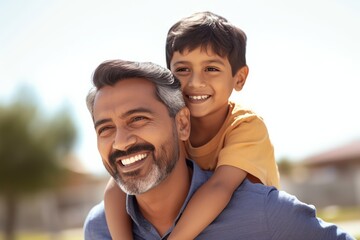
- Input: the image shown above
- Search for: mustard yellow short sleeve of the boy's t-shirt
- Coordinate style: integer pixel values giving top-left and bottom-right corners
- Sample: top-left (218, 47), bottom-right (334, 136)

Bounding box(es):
top-left (217, 114), bottom-right (279, 188)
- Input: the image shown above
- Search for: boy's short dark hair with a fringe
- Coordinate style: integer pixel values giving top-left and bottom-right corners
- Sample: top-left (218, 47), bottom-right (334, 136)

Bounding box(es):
top-left (166, 12), bottom-right (246, 76)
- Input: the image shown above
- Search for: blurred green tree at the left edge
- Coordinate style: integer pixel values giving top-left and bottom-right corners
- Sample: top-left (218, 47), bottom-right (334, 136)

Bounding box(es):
top-left (0, 89), bottom-right (76, 240)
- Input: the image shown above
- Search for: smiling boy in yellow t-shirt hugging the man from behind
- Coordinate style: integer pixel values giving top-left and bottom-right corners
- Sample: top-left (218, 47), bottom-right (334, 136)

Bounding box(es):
top-left (105, 12), bottom-right (279, 240)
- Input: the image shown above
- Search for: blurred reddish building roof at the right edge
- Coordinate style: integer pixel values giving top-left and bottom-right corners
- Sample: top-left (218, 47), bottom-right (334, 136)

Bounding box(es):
top-left (303, 139), bottom-right (360, 165)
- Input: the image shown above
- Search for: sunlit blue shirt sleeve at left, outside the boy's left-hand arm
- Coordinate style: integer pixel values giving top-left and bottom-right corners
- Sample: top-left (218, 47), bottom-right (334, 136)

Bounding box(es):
top-left (84, 202), bottom-right (111, 240)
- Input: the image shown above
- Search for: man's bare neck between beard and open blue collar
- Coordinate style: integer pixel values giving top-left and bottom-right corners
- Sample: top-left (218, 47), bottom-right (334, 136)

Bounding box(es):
top-left (136, 158), bottom-right (191, 236)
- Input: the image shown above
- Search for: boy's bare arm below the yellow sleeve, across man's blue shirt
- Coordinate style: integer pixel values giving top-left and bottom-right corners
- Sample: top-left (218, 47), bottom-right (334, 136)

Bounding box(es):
top-left (168, 165), bottom-right (247, 240)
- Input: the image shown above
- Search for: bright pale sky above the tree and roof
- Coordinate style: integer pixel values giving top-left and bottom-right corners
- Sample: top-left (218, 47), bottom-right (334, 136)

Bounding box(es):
top-left (0, 0), bottom-right (360, 173)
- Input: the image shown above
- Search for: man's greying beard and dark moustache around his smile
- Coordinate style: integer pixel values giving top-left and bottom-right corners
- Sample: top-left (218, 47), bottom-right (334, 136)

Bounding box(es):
top-left (109, 124), bottom-right (179, 195)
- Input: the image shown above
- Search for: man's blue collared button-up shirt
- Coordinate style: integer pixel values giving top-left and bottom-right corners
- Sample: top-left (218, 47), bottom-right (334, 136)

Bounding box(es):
top-left (84, 160), bottom-right (354, 240)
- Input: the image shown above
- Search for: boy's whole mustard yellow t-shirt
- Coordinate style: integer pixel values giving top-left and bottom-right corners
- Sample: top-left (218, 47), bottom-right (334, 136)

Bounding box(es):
top-left (185, 102), bottom-right (279, 188)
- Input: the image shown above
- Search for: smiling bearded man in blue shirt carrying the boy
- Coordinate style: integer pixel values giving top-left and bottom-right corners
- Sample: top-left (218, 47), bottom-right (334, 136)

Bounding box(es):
top-left (84, 60), bottom-right (353, 240)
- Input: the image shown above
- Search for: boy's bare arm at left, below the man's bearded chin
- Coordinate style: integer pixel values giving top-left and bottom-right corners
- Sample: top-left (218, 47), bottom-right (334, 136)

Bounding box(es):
top-left (104, 178), bottom-right (133, 240)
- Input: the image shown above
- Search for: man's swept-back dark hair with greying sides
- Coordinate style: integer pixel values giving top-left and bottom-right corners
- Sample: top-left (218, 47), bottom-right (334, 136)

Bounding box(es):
top-left (86, 60), bottom-right (185, 117)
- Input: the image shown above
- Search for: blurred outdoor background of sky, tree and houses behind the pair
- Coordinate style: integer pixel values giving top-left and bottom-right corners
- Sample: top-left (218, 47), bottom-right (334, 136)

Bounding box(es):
top-left (0, 0), bottom-right (360, 240)
